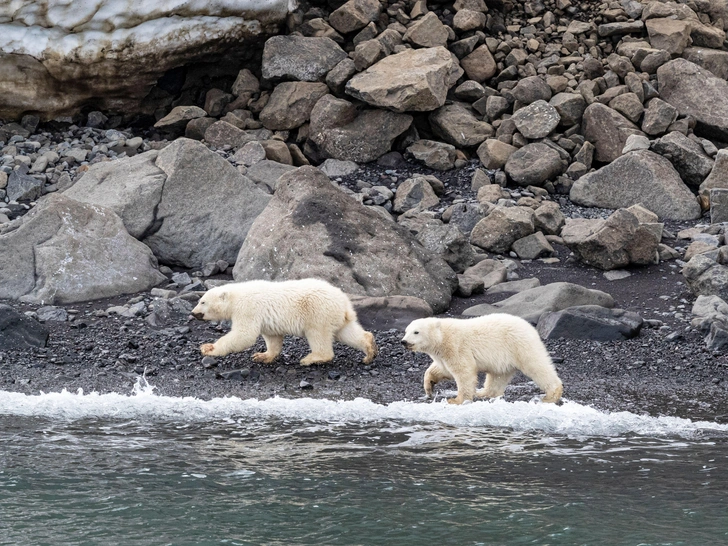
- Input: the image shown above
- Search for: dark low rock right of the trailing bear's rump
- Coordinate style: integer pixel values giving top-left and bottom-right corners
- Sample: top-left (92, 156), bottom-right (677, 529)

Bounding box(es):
top-left (536, 305), bottom-right (643, 341)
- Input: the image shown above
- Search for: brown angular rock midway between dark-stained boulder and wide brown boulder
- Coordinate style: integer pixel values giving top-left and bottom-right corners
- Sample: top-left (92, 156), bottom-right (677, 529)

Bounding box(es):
top-left (470, 206), bottom-right (534, 254)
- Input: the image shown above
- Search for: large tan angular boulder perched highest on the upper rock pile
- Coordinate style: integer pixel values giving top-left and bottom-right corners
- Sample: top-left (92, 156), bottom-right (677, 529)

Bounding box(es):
top-left (346, 47), bottom-right (463, 113)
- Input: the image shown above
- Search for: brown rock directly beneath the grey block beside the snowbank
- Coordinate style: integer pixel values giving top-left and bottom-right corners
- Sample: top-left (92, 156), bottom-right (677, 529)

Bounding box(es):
top-left (260, 82), bottom-right (329, 131)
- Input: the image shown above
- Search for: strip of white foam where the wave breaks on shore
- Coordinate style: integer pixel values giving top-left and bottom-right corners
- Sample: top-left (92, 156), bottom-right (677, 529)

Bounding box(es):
top-left (0, 378), bottom-right (728, 436)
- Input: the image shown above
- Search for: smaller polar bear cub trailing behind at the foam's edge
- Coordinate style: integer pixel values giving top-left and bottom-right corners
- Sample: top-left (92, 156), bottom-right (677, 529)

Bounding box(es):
top-left (402, 313), bottom-right (563, 404)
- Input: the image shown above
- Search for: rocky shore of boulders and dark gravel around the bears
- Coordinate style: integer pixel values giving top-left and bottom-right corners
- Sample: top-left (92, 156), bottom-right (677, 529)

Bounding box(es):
top-left (0, 0), bottom-right (728, 422)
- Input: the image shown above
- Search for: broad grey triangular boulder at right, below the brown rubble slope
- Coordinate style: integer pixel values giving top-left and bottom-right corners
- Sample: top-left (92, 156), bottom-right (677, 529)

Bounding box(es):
top-left (569, 150), bottom-right (700, 220)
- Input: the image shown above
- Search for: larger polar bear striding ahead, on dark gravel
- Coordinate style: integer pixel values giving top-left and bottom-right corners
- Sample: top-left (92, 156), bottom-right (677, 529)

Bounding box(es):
top-left (192, 279), bottom-right (378, 366)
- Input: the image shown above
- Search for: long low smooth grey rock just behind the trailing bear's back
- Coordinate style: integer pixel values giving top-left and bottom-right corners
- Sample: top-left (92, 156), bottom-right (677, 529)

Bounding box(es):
top-left (463, 282), bottom-right (614, 324)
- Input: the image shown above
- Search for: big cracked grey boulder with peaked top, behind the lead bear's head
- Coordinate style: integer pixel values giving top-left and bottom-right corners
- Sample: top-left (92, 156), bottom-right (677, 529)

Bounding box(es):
top-left (64, 138), bottom-right (270, 268)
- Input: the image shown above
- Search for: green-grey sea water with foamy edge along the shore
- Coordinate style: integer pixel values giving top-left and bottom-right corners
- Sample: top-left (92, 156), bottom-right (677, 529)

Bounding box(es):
top-left (0, 378), bottom-right (728, 545)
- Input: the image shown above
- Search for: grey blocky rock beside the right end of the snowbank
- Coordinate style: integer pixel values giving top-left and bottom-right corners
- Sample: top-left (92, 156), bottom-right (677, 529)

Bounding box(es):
top-left (262, 34), bottom-right (346, 82)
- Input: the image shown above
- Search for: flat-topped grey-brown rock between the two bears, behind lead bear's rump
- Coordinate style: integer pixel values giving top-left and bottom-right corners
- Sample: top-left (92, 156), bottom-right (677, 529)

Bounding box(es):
top-left (349, 294), bottom-right (432, 330)
